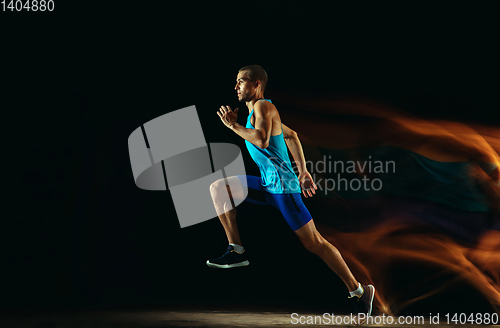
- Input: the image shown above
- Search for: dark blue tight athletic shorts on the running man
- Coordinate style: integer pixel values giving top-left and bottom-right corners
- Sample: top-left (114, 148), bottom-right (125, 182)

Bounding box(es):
top-left (237, 175), bottom-right (312, 231)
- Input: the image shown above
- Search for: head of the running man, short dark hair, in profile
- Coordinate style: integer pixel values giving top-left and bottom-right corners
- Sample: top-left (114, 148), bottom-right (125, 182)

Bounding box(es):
top-left (234, 65), bottom-right (267, 102)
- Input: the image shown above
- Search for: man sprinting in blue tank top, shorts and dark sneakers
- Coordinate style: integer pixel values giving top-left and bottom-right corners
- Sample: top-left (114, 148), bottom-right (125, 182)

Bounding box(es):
top-left (207, 65), bottom-right (375, 315)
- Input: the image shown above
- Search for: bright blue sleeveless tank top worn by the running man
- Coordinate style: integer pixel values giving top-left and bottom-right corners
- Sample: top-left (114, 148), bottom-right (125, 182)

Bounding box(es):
top-left (245, 99), bottom-right (300, 194)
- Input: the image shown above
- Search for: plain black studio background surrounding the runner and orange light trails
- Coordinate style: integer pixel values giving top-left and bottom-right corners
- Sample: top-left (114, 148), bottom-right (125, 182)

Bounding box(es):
top-left (0, 1), bottom-right (500, 313)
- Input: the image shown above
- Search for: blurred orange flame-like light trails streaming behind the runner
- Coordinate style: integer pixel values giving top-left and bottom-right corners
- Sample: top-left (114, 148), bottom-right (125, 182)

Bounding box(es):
top-left (273, 94), bottom-right (500, 314)
